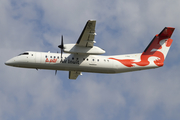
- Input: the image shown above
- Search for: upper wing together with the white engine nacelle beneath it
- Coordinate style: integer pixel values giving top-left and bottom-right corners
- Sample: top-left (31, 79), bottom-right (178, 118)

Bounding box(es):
top-left (63, 20), bottom-right (105, 55)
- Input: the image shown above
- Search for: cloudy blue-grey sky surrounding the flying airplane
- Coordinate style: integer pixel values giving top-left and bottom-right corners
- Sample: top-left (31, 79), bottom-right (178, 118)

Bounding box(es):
top-left (0, 0), bottom-right (180, 120)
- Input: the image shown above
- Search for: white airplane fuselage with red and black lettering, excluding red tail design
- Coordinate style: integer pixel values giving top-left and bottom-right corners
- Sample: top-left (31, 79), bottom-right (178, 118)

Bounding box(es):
top-left (5, 51), bottom-right (158, 73)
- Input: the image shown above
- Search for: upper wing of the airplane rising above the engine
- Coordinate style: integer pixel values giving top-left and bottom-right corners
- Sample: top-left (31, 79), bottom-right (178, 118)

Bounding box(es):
top-left (76, 20), bottom-right (96, 47)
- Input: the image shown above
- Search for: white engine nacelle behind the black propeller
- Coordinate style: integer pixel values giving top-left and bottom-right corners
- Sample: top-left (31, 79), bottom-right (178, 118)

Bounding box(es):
top-left (63, 44), bottom-right (105, 55)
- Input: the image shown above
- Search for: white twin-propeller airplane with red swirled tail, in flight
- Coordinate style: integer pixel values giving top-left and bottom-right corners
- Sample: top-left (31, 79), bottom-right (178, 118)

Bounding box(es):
top-left (5, 20), bottom-right (175, 80)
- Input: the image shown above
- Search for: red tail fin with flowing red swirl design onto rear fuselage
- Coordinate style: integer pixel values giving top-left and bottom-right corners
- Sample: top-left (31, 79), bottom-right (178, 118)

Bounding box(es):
top-left (109, 27), bottom-right (174, 67)
